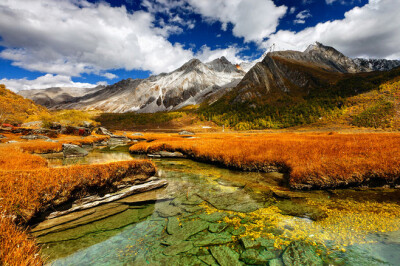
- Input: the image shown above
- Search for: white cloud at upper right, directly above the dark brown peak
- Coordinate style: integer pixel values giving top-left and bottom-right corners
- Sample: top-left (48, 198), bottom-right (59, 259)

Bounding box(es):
top-left (264, 0), bottom-right (400, 59)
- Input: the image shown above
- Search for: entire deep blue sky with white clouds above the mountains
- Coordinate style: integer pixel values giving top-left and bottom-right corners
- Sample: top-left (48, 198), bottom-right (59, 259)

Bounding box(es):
top-left (0, 0), bottom-right (400, 91)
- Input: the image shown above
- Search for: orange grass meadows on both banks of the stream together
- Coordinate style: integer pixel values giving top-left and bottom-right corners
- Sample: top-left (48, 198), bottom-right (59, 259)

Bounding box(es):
top-left (0, 129), bottom-right (400, 265)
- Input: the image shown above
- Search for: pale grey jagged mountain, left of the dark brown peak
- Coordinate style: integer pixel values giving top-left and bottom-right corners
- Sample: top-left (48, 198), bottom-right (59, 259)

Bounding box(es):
top-left (24, 57), bottom-right (245, 113)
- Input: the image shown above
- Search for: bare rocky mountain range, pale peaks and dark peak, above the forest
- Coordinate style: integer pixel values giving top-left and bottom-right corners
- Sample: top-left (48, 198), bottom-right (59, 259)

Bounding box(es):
top-left (20, 43), bottom-right (400, 113)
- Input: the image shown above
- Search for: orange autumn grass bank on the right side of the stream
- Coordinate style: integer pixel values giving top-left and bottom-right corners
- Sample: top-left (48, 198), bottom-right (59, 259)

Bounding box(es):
top-left (130, 133), bottom-right (400, 189)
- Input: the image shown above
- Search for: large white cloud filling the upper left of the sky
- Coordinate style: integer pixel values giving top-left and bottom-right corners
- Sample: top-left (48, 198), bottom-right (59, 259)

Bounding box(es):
top-left (0, 0), bottom-right (192, 76)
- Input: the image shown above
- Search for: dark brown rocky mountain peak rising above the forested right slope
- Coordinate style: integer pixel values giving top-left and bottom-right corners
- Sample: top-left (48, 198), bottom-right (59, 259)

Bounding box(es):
top-left (233, 42), bottom-right (400, 102)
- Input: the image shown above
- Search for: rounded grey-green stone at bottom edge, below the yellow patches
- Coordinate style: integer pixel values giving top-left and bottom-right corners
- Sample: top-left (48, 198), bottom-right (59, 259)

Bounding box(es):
top-left (282, 241), bottom-right (323, 266)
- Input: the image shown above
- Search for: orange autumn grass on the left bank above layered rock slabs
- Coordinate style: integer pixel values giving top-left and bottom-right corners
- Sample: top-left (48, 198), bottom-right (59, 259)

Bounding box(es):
top-left (0, 141), bottom-right (155, 265)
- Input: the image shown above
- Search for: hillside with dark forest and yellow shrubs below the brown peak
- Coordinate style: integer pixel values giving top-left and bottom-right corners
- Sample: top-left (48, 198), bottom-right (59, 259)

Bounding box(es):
top-left (198, 65), bottom-right (400, 130)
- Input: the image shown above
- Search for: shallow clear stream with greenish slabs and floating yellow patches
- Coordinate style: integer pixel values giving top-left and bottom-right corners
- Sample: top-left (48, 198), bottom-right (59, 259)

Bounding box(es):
top-left (32, 147), bottom-right (400, 265)
